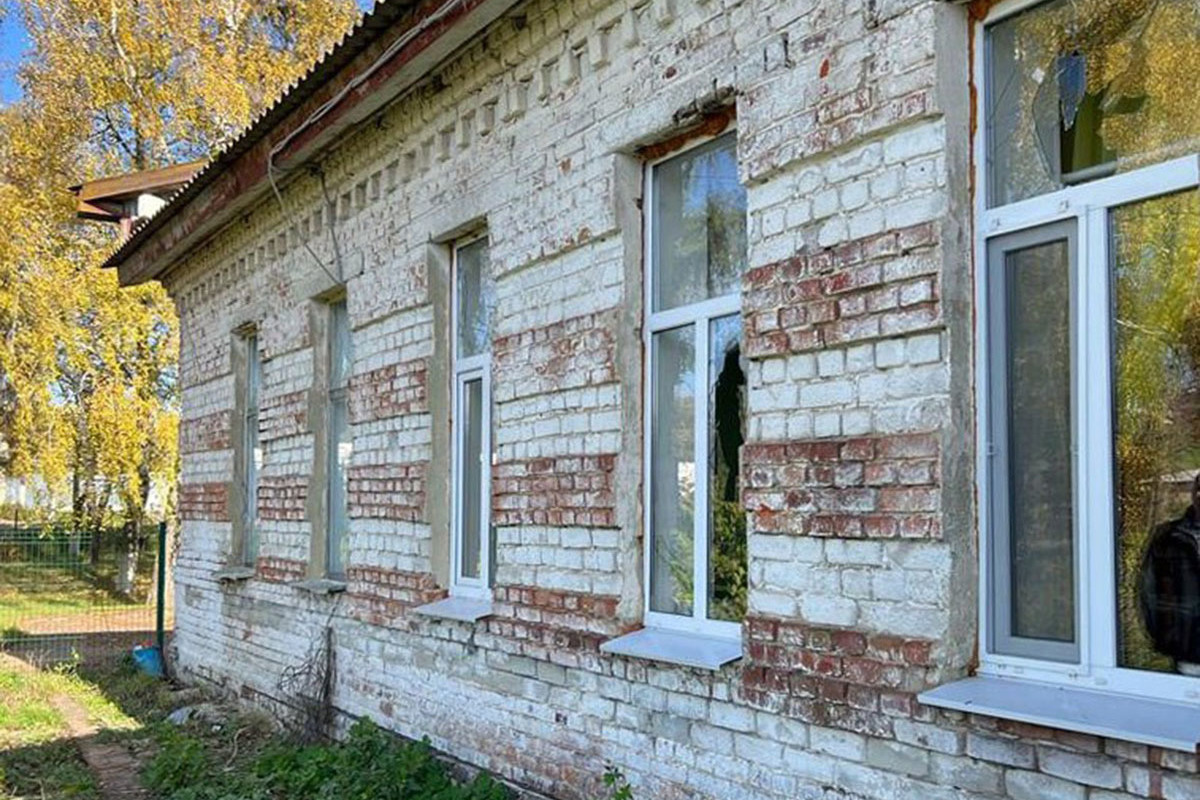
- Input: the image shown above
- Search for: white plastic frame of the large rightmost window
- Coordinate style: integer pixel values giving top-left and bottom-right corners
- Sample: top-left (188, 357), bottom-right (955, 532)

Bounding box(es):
top-left (972, 0), bottom-right (1200, 703)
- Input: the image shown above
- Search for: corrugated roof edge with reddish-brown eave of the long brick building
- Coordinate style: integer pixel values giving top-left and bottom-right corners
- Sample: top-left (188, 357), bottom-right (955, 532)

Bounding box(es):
top-left (104, 0), bottom-right (517, 284)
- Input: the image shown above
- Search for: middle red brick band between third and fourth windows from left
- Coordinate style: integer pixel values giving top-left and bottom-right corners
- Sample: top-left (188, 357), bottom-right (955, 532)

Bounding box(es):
top-left (492, 455), bottom-right (617, 528)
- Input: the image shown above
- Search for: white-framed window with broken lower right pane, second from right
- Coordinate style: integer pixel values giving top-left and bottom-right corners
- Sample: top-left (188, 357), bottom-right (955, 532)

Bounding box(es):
top-left (646, 133), bottom-right (746, 638)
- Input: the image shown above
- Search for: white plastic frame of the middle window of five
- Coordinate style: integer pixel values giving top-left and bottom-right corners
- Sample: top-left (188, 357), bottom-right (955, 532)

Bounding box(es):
top-left (450, 234), bottom-right (492, 600)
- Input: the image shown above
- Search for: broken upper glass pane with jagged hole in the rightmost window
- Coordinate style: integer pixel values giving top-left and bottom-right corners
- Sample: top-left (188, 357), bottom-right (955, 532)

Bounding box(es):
top-left (985, 0), bottom-right (1200, 206)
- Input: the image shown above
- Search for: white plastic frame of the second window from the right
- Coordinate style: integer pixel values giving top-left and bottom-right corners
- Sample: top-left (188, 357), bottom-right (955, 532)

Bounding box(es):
top-left (642, 125), bottom-right (744, 642)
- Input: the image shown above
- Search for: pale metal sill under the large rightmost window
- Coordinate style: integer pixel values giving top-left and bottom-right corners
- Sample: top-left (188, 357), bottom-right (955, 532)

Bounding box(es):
top-left (917, 676), bottom-right (1200, 753)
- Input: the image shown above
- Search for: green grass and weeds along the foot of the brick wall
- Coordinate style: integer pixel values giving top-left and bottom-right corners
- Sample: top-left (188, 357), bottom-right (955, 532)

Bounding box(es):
top-left (0, 656), bottom-right (632, 800)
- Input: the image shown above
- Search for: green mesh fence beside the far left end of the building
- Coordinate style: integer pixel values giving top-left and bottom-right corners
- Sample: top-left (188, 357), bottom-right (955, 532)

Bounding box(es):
top-left (0, 527), bottom-right (170, 663)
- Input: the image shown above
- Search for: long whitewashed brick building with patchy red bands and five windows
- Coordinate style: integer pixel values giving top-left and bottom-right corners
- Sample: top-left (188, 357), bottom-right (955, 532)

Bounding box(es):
top-left (109, 0), bottom-right (1200, 800)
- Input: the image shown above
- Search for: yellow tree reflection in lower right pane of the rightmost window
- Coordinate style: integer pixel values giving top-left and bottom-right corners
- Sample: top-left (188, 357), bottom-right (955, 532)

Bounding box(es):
top-left (1111, 191), bottom-right (1200, 669)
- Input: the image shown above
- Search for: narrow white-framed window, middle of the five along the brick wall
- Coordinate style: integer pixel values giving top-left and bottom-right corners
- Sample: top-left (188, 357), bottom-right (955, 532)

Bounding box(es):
top-left (451, 239), bottom-right (496, 600)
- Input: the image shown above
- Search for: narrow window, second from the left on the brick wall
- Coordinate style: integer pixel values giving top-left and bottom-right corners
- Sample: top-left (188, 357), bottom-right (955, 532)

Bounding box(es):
top-left (325, 299), bottom-right (354, 578)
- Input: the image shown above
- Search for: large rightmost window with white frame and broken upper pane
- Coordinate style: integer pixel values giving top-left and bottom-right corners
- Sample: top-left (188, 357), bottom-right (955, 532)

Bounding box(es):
top-left (977, 0), bottom-right (1200, 700)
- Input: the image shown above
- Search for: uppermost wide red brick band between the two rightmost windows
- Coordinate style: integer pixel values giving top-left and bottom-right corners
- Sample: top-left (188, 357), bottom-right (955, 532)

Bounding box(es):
top-left (743, 222), bottom-right (942, 357)
